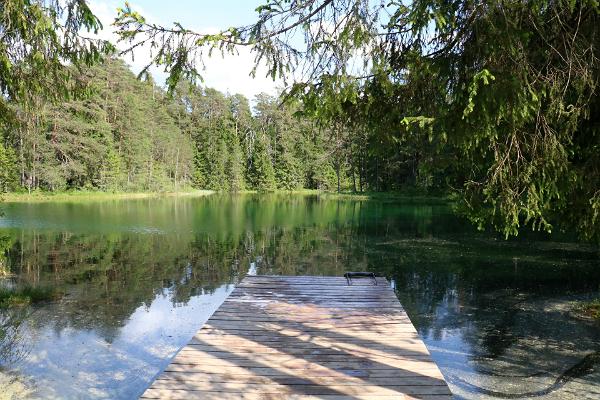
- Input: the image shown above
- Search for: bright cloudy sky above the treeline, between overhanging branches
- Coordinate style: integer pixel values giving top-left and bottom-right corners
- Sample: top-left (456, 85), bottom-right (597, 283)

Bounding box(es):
top-left (89, 0), bottom-right (282, 99)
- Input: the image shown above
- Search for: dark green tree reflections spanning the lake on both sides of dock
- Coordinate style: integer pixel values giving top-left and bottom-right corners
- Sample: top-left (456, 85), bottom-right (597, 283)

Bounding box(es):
top-left (0, 195), bottom-right (600, 376)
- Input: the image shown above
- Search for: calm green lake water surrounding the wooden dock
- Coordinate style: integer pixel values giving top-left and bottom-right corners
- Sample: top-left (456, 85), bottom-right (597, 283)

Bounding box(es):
top-left (0, 195), bottom-right (600, 399)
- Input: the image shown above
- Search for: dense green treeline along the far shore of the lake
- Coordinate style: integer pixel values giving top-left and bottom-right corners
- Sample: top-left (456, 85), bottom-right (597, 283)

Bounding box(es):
top-left (0, 58), bottom-right (416, 192)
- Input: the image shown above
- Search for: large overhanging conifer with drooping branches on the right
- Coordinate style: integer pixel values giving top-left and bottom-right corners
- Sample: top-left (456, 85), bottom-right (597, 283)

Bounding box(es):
top-left (117, 0), bottom-right (600, 241)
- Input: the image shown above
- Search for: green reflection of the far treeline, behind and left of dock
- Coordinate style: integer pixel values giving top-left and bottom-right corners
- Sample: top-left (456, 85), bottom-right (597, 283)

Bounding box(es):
top-left (0, 196), bottom-right (392, 340)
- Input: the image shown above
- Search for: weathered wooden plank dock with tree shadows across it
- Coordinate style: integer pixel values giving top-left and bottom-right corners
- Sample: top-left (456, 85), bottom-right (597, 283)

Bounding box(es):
top-left (141, 276), bottom-right (452, 400)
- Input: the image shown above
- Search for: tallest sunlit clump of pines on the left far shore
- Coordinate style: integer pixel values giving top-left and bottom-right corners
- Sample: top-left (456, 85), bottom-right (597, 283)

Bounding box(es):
top-left (3, 58), bottom-right (193, 191)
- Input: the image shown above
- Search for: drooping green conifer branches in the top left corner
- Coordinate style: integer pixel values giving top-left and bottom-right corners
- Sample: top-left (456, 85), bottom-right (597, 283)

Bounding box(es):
top-left (0, 0), bottom-right (113, 118)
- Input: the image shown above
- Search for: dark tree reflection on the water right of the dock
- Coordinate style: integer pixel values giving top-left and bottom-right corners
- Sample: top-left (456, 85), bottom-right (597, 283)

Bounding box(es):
top-left (378, 234), bottom-right (600, 379)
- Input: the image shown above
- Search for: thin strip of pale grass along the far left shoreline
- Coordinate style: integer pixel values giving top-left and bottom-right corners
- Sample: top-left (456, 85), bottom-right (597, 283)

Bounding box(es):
top-left (1, 190), bottom-right (214, 203)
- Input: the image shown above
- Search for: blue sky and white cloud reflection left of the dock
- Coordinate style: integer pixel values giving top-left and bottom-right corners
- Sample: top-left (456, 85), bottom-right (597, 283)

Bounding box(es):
top-left (14, 285), bottom-right (233, 399)
